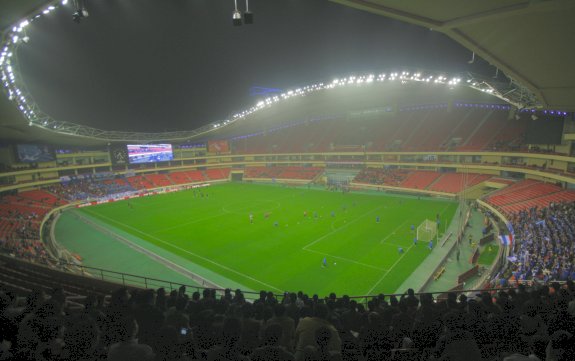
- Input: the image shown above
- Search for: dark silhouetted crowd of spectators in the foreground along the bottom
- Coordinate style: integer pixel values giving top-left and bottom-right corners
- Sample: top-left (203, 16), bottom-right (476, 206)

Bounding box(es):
top-left (0, 282), bottom-right (575, 361)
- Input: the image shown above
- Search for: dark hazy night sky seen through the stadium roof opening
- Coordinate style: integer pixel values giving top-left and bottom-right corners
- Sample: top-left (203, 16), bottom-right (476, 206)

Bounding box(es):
top-left (18, 0), bottom-right (480, 131)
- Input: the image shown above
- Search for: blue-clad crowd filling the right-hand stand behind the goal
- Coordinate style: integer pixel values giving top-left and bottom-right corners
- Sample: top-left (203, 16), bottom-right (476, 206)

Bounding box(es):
top-left (510, 203), bottom-right (575, 281)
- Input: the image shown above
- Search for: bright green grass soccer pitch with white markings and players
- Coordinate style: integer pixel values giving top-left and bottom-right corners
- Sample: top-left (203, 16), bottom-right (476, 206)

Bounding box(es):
top-left (81, 183), bottom-right (457, 295)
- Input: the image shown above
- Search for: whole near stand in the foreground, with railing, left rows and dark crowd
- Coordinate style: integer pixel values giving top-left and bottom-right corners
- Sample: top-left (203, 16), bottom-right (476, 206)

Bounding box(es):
top-left (4, 249), bottom-right (575, 361)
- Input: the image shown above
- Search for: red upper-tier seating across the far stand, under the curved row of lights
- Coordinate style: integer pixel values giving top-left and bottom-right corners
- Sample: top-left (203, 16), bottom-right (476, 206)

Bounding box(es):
top-left (231, 105), bottom-right (512, 154)
